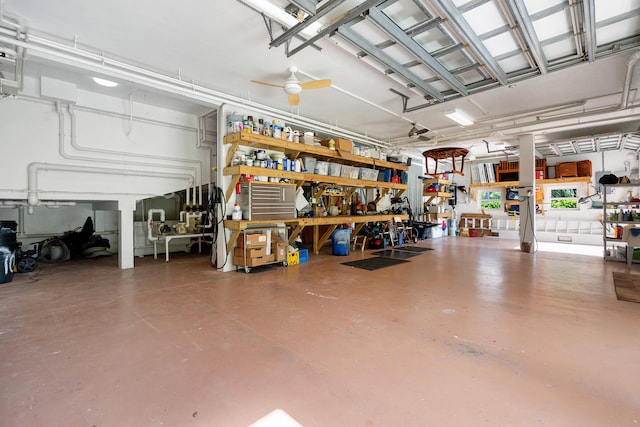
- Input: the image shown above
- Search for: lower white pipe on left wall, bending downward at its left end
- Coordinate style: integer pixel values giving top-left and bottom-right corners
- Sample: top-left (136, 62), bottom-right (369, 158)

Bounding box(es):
top-left (27, 162), bottom-right (194, 213)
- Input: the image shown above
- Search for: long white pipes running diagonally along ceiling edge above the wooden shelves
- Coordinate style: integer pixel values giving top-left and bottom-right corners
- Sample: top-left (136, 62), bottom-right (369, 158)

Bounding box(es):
top-left (0, 28), bottom-right (387, 146)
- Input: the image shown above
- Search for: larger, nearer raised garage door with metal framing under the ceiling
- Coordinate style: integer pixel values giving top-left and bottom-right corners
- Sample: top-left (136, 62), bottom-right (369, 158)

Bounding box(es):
top-left (272, 0), bottom-right (640, 108)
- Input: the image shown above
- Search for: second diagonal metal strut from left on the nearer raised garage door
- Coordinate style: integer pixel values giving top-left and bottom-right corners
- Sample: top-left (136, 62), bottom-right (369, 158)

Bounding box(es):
top-left (367, 7), bottom-right (469, 96)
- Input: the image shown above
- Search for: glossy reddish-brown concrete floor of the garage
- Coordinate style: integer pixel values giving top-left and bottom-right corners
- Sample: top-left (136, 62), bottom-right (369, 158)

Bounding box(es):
top-left (0, 237), bottom-right (640, 427)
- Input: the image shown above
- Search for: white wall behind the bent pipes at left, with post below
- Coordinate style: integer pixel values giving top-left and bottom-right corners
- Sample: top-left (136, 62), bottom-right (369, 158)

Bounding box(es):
top-left (0, 75), bottom-right (215, 266)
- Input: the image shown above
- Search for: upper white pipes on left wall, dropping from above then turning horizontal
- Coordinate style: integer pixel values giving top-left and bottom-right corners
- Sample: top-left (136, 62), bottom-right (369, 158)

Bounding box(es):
top-left (56, 101), bottom-right (202, 205)
